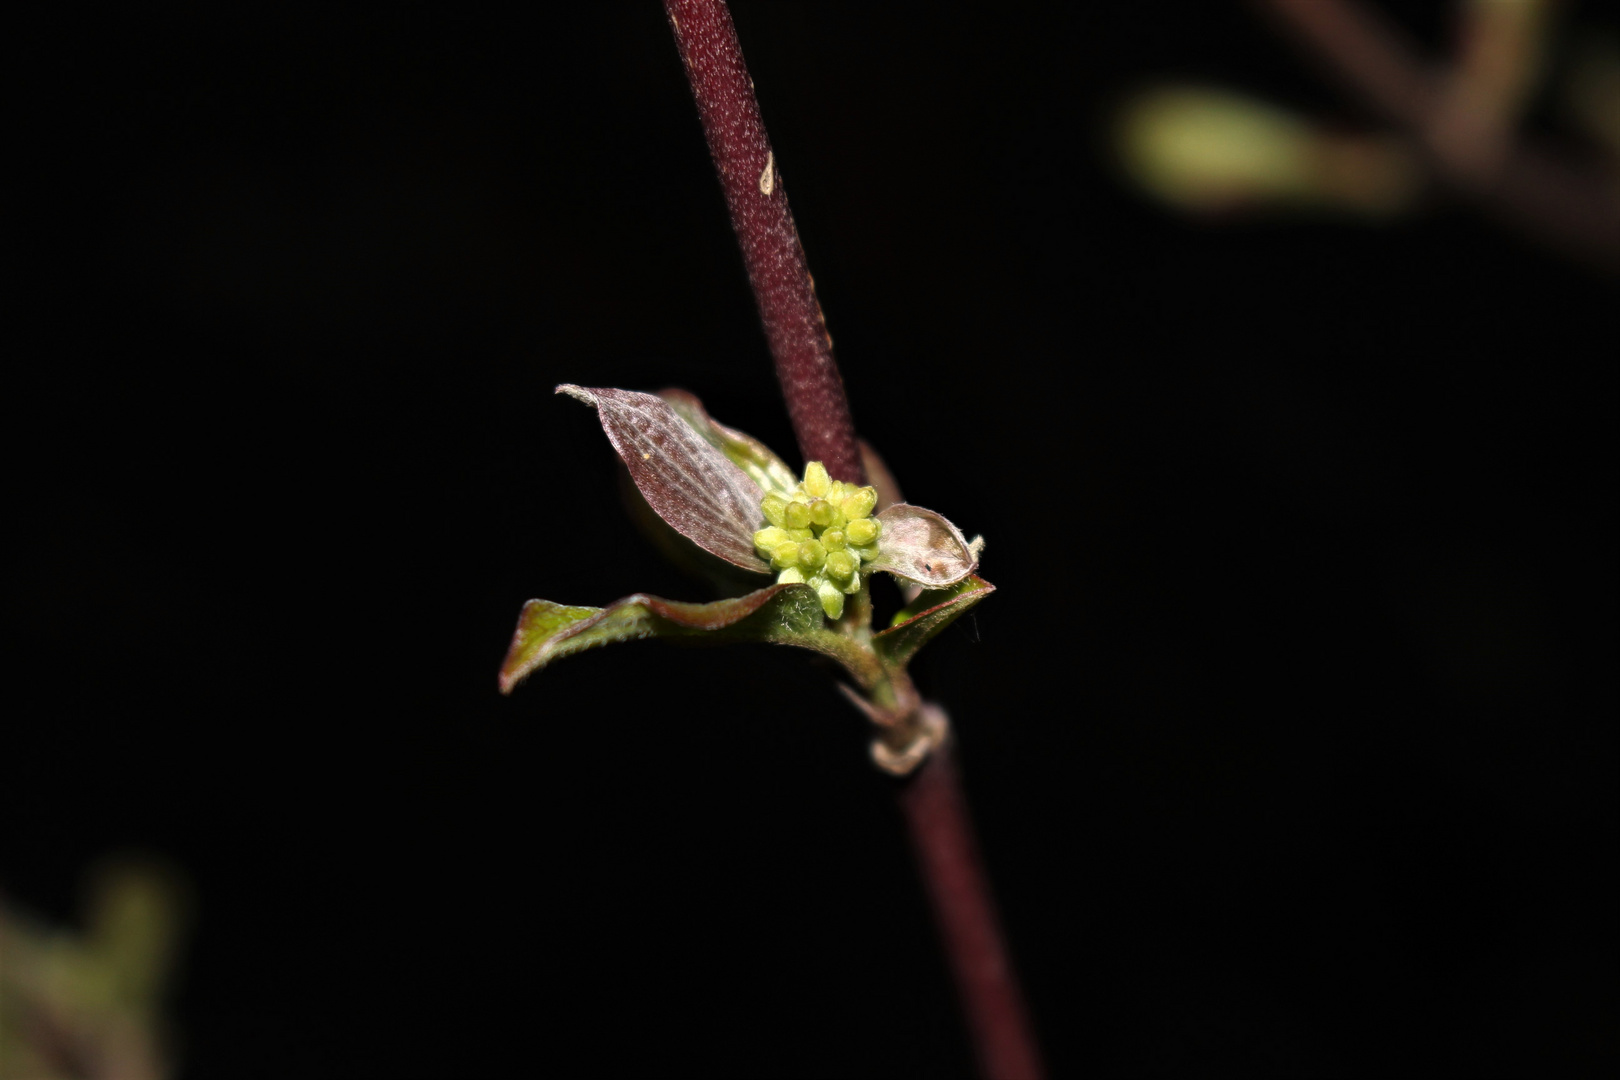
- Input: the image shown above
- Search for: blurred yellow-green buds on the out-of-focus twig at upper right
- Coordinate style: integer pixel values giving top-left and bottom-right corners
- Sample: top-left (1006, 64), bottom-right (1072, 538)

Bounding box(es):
top-left (1113, 0), bottom-right (1620, 241)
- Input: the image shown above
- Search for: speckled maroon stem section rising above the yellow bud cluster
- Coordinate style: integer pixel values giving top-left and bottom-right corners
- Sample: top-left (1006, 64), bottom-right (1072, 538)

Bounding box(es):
top-left (664, 0), bottom-right (865, 483)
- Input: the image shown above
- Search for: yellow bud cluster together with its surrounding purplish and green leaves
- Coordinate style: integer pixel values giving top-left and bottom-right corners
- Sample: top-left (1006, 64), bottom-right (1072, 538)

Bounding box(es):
top-left (501, 384), bottom-right (995, 772)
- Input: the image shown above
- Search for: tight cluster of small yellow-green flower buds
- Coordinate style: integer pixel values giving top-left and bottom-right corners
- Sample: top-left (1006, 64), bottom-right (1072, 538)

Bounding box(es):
top-left (753, 461), bottom-right (883, 619)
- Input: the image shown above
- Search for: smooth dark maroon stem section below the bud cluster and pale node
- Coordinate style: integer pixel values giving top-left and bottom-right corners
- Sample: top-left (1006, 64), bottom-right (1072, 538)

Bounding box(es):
top-left (901, 740), bottom-right (1043, 1080)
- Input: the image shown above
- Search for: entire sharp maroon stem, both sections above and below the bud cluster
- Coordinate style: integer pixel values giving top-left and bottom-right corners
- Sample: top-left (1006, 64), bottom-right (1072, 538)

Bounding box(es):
top-left (664, 0), bottom-right (1042, 1080)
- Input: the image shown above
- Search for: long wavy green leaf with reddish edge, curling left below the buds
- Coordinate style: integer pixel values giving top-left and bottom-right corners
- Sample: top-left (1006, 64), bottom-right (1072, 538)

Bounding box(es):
top-left (501, 585), bottom-right (873, 693)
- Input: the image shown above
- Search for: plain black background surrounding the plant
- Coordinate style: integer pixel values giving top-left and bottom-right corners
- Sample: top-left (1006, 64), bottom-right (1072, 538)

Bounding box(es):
top-left (9, 2), bottom-right (1620, 1078)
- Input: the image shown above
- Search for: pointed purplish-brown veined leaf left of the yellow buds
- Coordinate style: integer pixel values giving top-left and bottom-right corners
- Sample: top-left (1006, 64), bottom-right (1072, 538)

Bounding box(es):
top-left (557, 384), bottom-right (770, 573)
